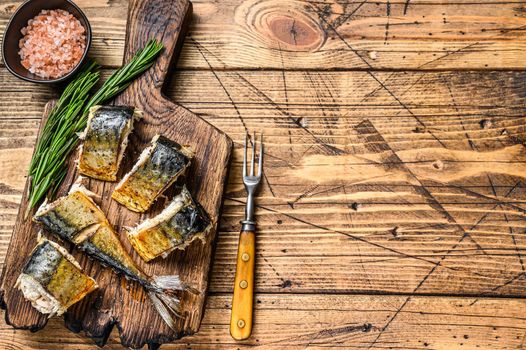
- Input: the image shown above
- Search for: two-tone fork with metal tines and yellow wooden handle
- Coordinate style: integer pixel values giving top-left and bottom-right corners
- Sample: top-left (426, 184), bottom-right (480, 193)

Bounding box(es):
top-left (230, 132), bottom-right (263, 340)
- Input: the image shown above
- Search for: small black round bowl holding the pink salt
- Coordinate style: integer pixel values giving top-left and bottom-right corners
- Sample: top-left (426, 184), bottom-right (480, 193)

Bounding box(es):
top-left (2, 0), bottom-right (91, 84)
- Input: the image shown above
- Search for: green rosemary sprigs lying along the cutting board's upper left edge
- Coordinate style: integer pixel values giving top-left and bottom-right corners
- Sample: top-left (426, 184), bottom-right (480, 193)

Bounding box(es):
top-left (29, 40), bottom-right (163, 208)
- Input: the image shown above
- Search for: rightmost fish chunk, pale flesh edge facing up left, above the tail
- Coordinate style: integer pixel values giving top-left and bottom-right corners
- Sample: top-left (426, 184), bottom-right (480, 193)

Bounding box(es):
top-left (128, 187), bottom-right (212, 262)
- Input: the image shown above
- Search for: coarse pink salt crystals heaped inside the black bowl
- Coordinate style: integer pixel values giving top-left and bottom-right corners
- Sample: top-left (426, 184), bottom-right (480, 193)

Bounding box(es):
top-left (18, 10), bottom-right (86, 79)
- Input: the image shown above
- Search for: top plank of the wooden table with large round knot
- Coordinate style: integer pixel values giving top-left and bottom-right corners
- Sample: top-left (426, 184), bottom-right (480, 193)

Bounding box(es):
top-left (0, 0), bottom-right (526, 69)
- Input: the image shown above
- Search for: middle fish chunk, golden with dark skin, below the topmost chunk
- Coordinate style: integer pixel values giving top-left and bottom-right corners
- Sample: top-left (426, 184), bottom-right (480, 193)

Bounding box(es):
top-left (112, 135), bottom-right (193, 213)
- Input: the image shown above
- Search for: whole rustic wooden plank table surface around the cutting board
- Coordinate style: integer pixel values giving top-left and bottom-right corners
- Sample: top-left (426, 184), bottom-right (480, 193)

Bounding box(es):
top-left (0, 0), bottom-right (526, 349)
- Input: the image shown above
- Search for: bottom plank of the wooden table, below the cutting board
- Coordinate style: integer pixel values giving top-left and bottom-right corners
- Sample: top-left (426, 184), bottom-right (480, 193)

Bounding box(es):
top-left (0, 294), bottom-right (526, 350)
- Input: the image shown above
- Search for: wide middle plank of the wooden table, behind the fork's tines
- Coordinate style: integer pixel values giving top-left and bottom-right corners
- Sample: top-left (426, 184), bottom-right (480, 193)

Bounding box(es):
top-left (0, 71), bottom-right (526, 296)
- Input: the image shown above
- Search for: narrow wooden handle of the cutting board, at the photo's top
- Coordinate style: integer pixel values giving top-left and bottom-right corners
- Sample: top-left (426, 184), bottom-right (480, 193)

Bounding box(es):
top-left (119, 0), bottom-right (192, 100)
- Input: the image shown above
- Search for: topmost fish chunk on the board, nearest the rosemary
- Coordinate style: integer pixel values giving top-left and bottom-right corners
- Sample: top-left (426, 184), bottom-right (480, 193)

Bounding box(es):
top-left (78, 106), bottom-right (140, 181)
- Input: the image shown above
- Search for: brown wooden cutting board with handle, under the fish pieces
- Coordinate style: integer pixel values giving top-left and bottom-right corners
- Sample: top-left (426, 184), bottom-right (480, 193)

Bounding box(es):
top-left (0, 0), bottom-right (232, 348)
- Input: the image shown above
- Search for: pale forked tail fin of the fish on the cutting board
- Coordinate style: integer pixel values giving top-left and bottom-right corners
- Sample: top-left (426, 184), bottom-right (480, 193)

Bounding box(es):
top-left (148, 275), bottom-right (199, 330)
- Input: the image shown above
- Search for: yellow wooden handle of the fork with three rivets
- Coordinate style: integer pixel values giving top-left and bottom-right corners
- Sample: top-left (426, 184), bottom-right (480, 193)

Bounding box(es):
top-left (230, 230), bottom-right (256, 340)
